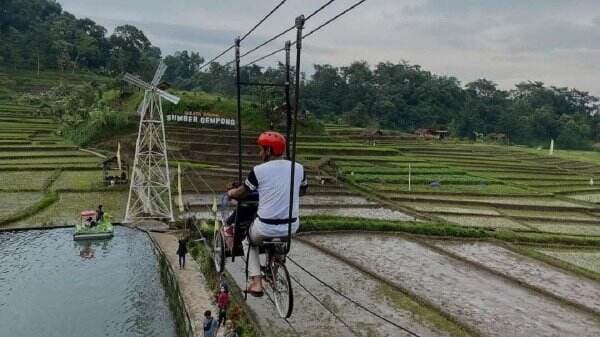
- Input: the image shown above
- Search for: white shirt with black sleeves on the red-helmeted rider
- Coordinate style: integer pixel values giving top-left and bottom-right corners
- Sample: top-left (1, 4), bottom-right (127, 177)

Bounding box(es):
top-left (244, 159), bottom-right (307, 237)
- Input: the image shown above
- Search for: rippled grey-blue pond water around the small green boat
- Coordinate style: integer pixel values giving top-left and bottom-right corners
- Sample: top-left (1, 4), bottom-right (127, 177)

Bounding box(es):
top-left (0, 227), bottom-right (175, 337)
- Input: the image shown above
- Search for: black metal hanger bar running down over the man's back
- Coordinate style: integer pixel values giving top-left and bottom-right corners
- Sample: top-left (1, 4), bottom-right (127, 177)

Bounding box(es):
top-left (285, 15), bottom-right (304, 254)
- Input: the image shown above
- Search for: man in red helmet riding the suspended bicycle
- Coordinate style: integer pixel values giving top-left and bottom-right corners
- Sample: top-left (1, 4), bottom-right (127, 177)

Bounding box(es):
top-left (227, 131), bottom-right (307, 296)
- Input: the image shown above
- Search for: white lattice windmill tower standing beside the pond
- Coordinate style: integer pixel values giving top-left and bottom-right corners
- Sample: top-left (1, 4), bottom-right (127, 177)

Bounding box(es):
top-left (123, 61), bottom-right (179, 223)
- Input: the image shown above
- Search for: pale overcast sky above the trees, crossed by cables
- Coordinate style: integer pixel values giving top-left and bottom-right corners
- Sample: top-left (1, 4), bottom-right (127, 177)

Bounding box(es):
top-left (59, 0), bottom-right (600, 95)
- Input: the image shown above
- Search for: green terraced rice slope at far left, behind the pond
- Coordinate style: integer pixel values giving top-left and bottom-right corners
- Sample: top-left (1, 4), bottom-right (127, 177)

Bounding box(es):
top-left (0, 101), bottom-right (125, 227)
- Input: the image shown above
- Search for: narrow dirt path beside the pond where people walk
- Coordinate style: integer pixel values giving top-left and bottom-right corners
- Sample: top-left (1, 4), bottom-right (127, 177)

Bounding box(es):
top-left (150, 233), bottom-right (216, 337)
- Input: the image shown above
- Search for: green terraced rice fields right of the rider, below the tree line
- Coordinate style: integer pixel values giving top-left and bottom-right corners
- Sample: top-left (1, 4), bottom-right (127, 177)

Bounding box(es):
top-left (298, 126), bottom-right (600, 235)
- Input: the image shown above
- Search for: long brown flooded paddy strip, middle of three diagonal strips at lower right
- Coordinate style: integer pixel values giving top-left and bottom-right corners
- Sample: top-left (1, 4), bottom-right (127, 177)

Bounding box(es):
top-left (305, 235), bottom-right (600, 337)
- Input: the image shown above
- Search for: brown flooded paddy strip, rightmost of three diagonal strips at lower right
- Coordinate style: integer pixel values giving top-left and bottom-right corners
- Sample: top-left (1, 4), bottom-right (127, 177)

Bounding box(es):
top-left (429, 241), bottom-right (600, 312)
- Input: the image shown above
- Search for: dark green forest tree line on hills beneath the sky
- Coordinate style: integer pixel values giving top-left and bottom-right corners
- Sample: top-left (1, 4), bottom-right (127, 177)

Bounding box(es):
top-left (0, 0), bottom-right (600, 149)
